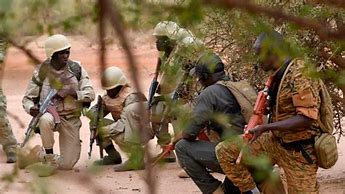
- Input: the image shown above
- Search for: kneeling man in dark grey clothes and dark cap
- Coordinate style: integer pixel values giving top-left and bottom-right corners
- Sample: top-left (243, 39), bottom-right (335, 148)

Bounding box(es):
top-left (175, 53), bottom-right (245, 193)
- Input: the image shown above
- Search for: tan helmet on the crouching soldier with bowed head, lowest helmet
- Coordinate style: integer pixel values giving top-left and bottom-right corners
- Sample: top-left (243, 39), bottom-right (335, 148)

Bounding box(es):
top-left (101, 66), bottom-right (128, 90)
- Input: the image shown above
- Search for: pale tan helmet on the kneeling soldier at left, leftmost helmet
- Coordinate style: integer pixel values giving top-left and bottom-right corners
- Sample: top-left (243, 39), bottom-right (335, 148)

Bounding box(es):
top-left (44, 34), bottom-right (71, 58)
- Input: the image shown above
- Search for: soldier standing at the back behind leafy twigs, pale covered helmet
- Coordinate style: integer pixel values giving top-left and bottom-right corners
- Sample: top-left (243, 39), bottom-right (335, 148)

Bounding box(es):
top-left (151, 21), bottom-right (204, 165)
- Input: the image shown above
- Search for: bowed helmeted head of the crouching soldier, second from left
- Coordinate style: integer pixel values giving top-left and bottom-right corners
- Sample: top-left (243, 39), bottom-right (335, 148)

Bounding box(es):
top-left (101, 66), bottom-right (128, 98)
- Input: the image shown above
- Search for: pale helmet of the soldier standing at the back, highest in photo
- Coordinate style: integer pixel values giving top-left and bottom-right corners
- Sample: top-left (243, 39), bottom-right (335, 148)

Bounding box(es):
top-left (153, 21), bottom-right (180, 40)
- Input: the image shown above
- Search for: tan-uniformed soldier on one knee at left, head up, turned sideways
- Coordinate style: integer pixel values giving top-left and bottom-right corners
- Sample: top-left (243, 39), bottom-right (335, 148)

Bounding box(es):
top-left (19, 34), bottom-right (95, 173)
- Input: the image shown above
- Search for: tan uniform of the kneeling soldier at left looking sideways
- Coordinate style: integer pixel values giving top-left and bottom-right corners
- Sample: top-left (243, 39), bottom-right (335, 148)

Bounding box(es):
top-left (22, 60), bottom-right (95, 170)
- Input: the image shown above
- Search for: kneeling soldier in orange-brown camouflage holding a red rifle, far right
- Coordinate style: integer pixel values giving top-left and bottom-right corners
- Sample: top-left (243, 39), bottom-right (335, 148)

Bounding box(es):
top-left (216, 31), bottom-right (320, 194)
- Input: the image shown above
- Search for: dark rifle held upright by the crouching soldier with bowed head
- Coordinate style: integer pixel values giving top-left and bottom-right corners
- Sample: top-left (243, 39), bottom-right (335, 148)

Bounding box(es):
top-left (88, 95), bottom-right (103, 159)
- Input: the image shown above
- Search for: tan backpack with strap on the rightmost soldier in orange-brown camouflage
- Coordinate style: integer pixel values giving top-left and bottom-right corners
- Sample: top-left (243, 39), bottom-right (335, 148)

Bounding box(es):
top-left (276, 59), bottom-right (338, 169)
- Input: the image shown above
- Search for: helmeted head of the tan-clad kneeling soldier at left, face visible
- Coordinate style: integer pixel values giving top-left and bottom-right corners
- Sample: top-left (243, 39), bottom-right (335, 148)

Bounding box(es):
top-left (45, 34), bottom-right (71, 69)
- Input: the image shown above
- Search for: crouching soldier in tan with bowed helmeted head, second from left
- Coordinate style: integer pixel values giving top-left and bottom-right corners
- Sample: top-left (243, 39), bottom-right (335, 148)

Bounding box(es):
top-left (88, 67), bottom-right (154, 171)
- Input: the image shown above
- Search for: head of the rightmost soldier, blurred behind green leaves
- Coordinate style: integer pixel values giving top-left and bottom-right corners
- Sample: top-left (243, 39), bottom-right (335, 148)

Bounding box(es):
top-left (253, 30), bottom-right (289, 71)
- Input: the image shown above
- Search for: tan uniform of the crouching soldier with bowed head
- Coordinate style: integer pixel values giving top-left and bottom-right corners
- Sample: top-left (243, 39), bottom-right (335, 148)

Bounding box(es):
top-left (91, 86), bottom-right (154, 150)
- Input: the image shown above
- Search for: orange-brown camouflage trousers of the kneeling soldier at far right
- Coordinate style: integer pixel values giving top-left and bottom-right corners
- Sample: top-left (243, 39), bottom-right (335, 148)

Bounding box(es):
top-left (216, 132), bottom-right (319, 194)
